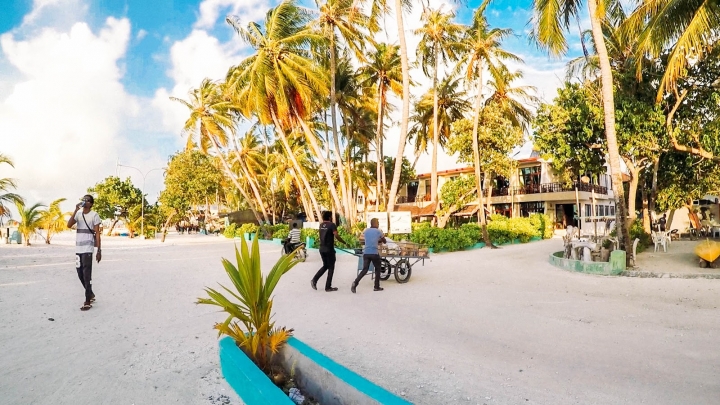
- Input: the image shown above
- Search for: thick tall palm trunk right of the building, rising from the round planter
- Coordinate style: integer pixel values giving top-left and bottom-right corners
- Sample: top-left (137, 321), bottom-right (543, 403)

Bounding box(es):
top-left (588, 0), bottom-right (630, 256)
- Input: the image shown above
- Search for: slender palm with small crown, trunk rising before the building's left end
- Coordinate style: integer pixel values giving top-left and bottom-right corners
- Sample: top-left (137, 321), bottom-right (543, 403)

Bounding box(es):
top-left (457, 0), bottom-right (521, 246)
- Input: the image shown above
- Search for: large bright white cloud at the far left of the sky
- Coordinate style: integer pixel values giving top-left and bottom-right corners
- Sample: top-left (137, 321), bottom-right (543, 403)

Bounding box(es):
top-left (0, 18), bottom-right (139, 208)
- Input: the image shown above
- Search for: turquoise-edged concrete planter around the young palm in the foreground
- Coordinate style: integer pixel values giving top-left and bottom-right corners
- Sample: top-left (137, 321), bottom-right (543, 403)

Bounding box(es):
top-left (220, 337), bottom-right (410, 405)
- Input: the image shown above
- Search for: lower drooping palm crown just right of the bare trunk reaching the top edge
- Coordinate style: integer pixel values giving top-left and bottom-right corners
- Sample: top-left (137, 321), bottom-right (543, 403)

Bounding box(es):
top-left (409, 78), bottom-right (471, 168)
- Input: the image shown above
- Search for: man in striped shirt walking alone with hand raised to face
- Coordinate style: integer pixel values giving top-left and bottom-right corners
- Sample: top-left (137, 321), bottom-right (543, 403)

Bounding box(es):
top-left (67, 194), bottom-right (102, 311)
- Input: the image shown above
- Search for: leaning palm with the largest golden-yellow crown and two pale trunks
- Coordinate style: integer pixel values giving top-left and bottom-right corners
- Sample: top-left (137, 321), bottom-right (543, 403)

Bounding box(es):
top-left (227, 0), bottom-right (342, 218)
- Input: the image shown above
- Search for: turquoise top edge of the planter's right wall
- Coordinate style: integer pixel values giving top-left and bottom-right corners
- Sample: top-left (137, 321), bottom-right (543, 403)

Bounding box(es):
top-left (287, 337), bottom-right (412, 405)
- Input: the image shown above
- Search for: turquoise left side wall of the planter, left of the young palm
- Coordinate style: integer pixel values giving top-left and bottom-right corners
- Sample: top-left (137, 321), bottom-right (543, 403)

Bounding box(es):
top-left (220, 336), bottom-right (294, 405)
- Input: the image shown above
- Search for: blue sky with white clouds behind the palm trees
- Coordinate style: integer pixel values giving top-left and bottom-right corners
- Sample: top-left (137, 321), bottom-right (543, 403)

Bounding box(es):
top-left (0, 0), bottom-right (588, 216)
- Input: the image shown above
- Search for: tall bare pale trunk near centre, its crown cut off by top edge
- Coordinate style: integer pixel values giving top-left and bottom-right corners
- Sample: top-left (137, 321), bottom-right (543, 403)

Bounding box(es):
top-left (387, 0), bottom-right (410, 212)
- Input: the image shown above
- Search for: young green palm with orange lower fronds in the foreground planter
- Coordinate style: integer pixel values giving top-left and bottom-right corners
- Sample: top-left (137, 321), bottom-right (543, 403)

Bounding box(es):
top-left (197, 235), bottom-right (300, 372)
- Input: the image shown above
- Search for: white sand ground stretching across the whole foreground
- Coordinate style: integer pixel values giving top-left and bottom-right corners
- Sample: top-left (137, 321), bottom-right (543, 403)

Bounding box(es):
top-left (0, 233), bottom-right (720, 405)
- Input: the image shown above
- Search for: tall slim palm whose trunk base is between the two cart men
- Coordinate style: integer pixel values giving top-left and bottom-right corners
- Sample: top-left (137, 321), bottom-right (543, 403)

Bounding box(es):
top-left (315, 0), bottom-right (370, 222)
